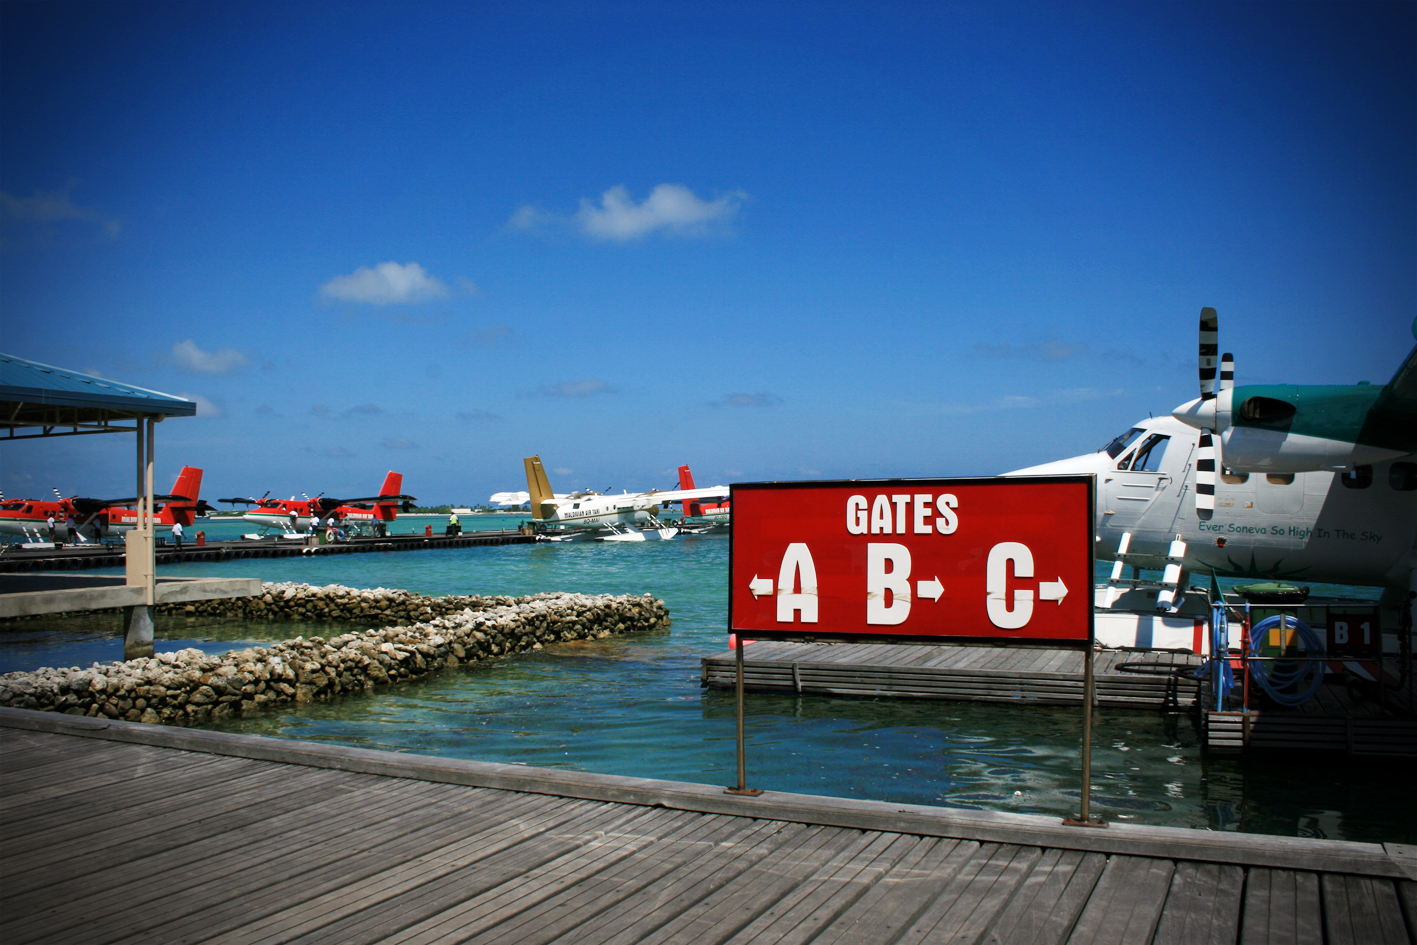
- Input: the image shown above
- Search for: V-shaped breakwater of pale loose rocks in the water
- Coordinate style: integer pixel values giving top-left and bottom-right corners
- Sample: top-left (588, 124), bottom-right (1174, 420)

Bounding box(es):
top-left (0, 585), bottom-right (669, 725)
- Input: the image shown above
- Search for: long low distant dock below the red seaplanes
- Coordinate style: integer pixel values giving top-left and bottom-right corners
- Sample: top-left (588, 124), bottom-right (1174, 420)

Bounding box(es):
top-left (0, 530), bottom-right (536, 574)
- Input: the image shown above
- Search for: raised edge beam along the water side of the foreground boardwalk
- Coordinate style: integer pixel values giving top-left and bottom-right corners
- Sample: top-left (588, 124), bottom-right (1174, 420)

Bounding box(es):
top-left (0, 707), bottom-right (1417, 880)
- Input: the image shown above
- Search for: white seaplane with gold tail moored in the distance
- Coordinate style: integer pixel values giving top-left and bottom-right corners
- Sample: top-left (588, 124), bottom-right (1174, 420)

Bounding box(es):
top-left (490, 456), bottom-right (728, 541)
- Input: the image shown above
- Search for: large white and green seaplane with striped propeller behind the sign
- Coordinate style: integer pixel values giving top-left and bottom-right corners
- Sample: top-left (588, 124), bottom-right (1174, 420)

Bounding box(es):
top-left (1005, 307), bottom-right (1417, 646)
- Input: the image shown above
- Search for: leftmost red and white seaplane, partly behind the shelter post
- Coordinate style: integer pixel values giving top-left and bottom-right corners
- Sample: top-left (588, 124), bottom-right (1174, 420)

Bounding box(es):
top-left (0, 466), bottom-right (214, 547)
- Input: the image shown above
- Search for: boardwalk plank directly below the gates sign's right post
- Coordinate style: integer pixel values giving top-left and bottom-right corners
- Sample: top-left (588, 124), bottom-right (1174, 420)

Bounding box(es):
top-left (985, 850), bottom-right (1107, 945)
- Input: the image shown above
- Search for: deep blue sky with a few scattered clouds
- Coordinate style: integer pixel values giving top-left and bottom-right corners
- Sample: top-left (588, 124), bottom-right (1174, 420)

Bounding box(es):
top-left (0, 3), bottom-right (1417, 503)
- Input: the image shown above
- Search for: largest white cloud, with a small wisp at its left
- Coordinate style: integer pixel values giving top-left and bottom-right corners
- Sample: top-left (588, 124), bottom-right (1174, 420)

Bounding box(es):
top-left (507, 184), bottom-right (748, 242)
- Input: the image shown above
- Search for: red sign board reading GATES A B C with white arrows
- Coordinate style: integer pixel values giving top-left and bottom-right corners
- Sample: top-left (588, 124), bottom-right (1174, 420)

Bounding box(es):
top-left (728, 476), bottom-right (1095, 645)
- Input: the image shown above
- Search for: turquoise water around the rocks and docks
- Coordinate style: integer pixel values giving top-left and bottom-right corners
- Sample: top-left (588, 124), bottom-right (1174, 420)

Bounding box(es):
top-left (0, 516), bottom-right (1417, 843)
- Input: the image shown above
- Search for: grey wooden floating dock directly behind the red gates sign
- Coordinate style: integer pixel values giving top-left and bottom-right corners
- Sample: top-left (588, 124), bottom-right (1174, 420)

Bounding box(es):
top-left (700, 640), bottom-right (1202, 710)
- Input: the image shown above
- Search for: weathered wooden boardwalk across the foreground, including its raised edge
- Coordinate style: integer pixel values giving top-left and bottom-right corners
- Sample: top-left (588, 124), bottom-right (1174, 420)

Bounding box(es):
top-left (0, 710), bottom-right (1417, 945)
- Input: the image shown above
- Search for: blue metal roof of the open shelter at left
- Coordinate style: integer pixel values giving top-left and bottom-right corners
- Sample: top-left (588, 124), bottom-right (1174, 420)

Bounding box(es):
top-left (0, 353), bottom-right (197, 439)
